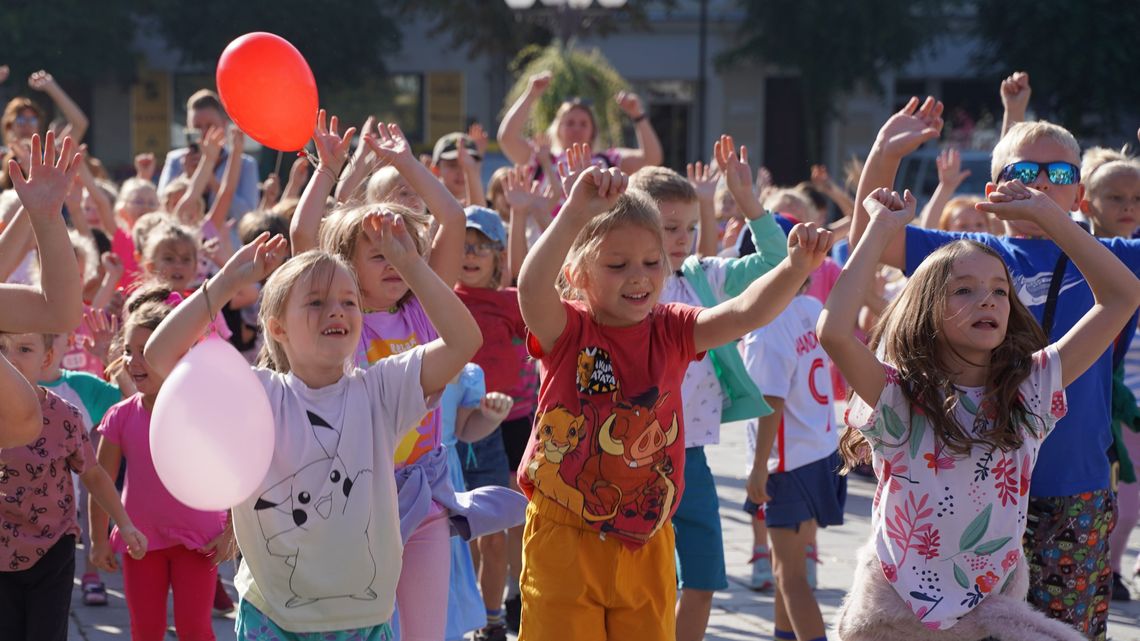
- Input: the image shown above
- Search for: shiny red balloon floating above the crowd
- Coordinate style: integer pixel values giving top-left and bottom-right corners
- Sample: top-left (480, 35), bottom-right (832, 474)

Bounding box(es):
top-left (217, 32), bottom-right (318, 152)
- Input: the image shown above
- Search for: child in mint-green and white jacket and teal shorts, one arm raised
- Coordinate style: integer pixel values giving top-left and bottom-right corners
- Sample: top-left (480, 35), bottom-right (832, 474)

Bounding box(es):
top-left (629, 136), bottom-right (788, 641)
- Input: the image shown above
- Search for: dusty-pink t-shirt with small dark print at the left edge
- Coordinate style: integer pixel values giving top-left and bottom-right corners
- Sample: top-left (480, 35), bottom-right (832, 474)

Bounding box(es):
top-left (0, 388), bottom-right (95, 571)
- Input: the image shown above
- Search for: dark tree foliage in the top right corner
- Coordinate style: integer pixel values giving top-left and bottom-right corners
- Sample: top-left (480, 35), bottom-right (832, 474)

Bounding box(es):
top-left (975, 0), bottom-right (1140, 136)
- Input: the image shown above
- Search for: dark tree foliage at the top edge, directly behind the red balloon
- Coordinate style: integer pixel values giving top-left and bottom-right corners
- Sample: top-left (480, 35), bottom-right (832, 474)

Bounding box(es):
top-left (140, 0), bottom-right (400, 87)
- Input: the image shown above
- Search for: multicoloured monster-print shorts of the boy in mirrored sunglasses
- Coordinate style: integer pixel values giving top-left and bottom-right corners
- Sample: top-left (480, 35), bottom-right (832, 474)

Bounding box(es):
top-left (1023, 489), bottom-right (1116, 641)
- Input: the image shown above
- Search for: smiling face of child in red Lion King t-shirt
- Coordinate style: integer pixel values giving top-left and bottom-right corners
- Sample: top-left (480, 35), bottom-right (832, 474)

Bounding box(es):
top-left (581, 225), bottom-right (666, 327)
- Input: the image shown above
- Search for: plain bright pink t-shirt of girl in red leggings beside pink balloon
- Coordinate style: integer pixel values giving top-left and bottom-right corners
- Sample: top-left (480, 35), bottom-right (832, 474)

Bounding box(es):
top-left (99, 393), bottom-right (226, 552)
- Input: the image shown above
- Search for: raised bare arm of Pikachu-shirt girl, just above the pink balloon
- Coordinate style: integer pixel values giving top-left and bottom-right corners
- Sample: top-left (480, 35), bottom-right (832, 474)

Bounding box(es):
top-left (143, 232), bottom-right (287, 378)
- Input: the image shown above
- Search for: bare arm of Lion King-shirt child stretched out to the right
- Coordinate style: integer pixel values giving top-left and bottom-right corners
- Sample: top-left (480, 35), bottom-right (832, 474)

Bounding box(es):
top-left (693, 224), bottom-right (832, 351)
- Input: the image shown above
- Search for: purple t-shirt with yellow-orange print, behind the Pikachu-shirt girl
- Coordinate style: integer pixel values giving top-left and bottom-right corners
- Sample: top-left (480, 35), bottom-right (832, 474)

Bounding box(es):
top-left (356, 297), bottom-right (442, 470)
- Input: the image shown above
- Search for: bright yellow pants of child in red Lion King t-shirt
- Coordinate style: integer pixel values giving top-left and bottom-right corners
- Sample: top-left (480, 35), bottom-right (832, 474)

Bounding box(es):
top-left (519, 492), bottom-right (677, 641)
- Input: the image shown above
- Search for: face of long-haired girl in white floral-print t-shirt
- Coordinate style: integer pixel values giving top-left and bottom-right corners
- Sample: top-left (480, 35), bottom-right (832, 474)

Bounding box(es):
top-left (939, 250), bottom-right (1011, 364)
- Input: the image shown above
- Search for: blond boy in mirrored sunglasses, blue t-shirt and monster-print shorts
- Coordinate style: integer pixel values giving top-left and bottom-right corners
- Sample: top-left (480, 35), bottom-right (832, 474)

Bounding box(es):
top-left (852, 91), bottom-right (1140, 639)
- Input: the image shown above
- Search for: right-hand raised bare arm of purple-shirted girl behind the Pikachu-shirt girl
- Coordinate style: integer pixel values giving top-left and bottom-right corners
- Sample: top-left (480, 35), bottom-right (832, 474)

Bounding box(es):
top-left (365, 122), bottom-right (467, 287)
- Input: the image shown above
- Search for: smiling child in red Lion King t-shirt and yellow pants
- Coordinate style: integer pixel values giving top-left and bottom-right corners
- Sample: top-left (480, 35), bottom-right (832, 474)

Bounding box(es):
top-left (518, 146), bottom-right (831, 641)
